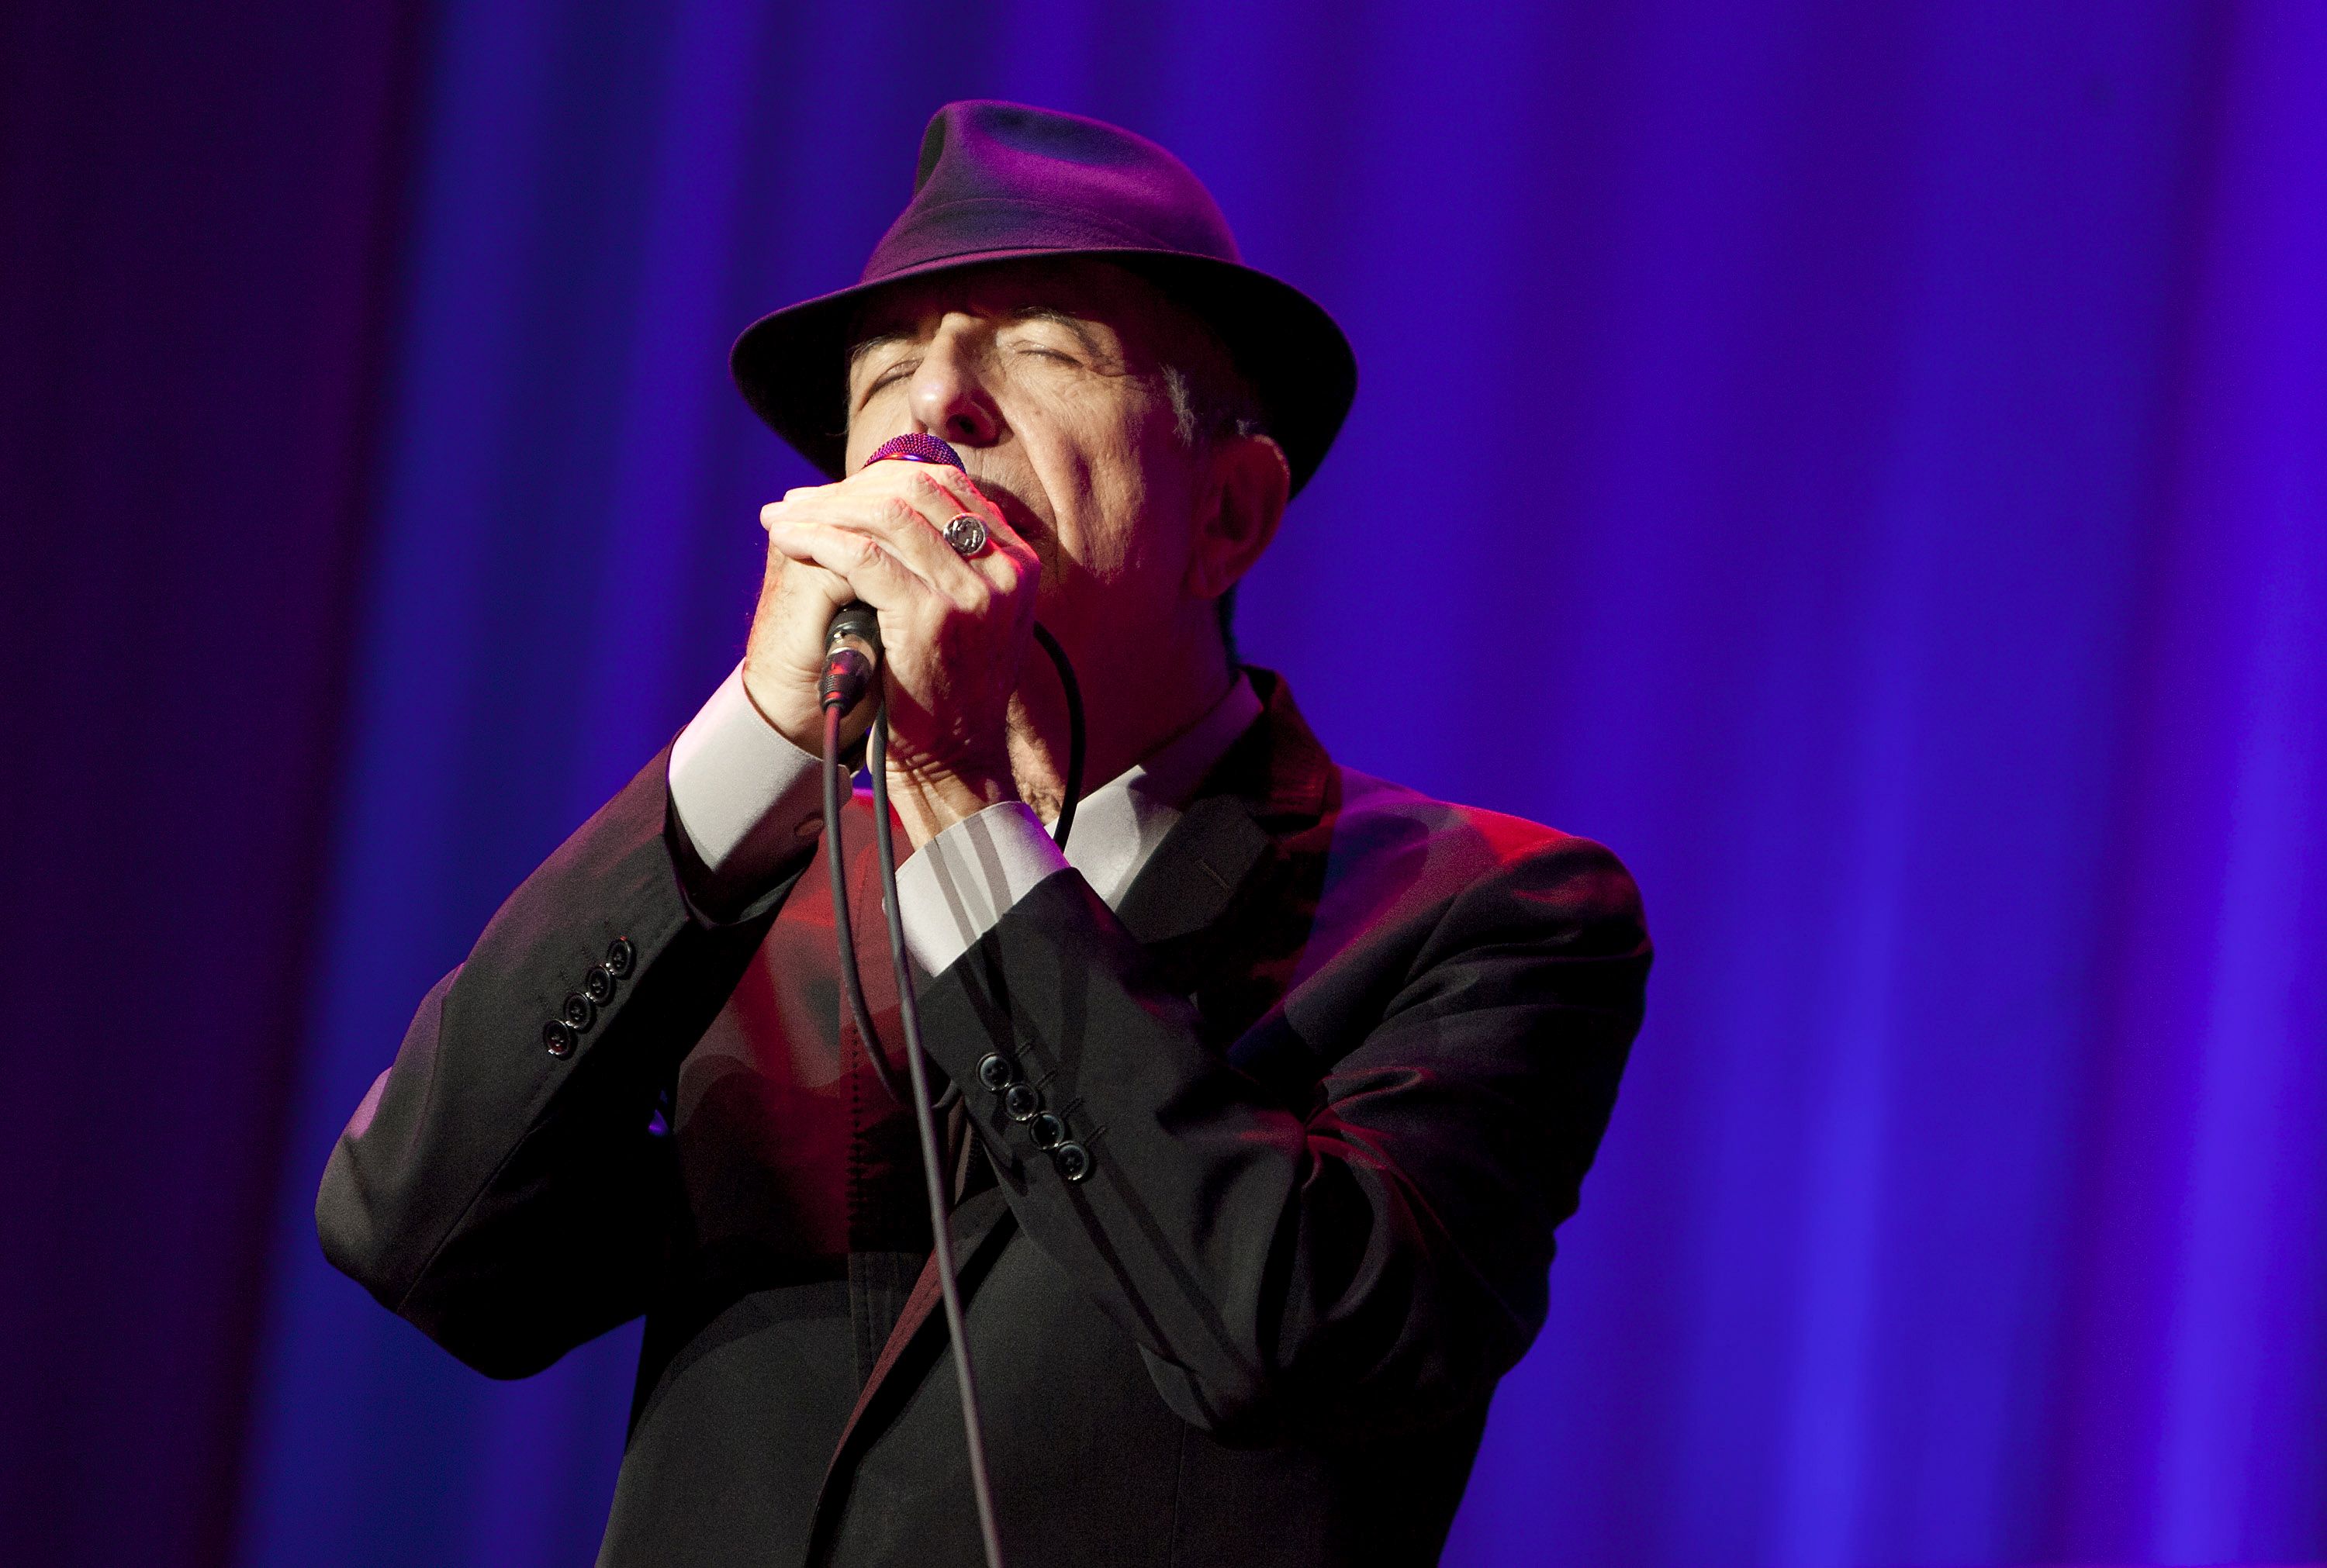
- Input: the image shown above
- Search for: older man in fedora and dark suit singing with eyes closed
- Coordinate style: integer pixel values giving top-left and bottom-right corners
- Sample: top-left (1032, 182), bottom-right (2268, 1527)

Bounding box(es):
top-left (316, 102), bottom-right (1648, 1566)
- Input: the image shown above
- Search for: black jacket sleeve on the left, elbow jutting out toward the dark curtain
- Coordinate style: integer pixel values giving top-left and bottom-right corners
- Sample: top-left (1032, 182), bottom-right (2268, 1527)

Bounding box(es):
top-left (314, 754), bottom-right (810, 1377)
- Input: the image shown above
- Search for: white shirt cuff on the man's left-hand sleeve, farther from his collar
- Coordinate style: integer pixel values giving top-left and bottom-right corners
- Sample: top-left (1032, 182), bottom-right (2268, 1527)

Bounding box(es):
top-left (670, 665), bottom-right (824, 891)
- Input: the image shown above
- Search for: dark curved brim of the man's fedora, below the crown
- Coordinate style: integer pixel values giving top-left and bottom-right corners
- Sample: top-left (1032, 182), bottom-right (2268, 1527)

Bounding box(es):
top-left (728, 247), bottom-right (1357, 493)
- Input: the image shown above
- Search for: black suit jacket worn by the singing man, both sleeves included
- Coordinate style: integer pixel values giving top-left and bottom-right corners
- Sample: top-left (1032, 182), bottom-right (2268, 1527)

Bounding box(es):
top-left (316, 672), bottom-right (1650, 1566)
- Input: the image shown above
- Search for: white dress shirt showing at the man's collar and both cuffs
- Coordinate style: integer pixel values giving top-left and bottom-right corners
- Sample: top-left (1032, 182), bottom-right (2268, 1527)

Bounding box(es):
top-left (670, 665), bottom-right (1261, 975)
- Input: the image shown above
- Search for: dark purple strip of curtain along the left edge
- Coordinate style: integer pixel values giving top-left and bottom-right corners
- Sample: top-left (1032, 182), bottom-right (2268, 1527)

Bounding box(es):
top-left (0, 0), bottom-right (419, 1568)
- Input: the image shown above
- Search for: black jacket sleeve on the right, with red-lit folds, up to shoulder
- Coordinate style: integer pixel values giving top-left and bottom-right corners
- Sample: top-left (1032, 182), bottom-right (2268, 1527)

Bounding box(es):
top-left (921, 838), bottom-right (1650, 1435)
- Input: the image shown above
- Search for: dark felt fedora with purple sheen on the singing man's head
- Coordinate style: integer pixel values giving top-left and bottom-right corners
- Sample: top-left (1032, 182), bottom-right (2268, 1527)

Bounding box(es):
top-left (728, 100), bottom-right (1357, 491)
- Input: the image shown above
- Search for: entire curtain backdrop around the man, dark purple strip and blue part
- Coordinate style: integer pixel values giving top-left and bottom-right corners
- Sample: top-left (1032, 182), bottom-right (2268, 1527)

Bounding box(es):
top-left (0, 0), bottom-right (2327, 1568)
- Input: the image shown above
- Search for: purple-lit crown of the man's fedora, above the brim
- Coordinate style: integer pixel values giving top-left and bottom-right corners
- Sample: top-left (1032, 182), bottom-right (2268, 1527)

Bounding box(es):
top-left (859, 100), bottom-right (1243, 284)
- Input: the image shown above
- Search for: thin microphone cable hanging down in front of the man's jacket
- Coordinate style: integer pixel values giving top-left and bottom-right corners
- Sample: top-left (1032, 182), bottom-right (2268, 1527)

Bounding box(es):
top-left (819, 605), bottom-right (1087, 1568)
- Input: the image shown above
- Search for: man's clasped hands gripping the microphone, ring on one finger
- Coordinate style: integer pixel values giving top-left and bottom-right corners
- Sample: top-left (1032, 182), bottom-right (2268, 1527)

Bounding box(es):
top-left (742, 461), bottom-right (1040, 847)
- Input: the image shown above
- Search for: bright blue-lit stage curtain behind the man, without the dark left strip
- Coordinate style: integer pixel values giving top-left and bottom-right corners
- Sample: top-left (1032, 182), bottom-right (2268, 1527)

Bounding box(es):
top-left (50, 0), bottom-right (2327, 1568)
